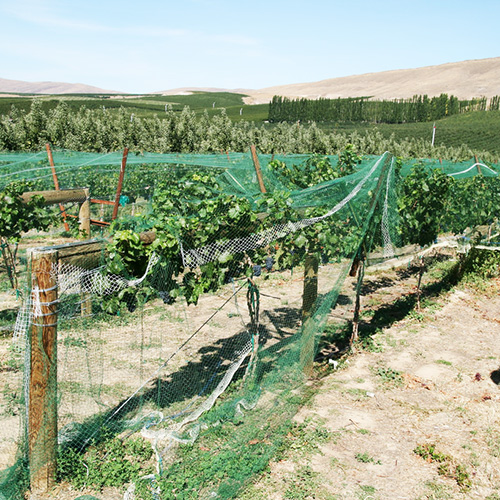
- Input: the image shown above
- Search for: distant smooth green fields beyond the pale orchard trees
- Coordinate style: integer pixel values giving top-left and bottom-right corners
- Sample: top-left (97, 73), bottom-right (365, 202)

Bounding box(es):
top-left (0, 92), bottom-right (500, 154)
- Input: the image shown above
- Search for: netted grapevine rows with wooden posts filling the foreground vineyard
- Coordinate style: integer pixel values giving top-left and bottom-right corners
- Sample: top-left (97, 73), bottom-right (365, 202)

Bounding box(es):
top-left (0, 146), bottom-right (500, 500)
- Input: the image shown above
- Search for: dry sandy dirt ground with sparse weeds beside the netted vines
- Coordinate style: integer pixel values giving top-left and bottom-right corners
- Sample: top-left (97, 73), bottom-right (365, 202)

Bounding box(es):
top-left (0, 250), bottom-right (500, 500)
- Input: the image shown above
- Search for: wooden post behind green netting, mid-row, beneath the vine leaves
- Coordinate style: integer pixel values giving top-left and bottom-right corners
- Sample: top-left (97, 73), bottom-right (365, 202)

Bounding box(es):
top-left (300, 253), bottom-right (319, 377)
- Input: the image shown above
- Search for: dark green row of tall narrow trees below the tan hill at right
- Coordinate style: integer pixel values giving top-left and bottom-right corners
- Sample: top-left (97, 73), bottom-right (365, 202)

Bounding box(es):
top-left (269, 94), bottom-right (500, 123)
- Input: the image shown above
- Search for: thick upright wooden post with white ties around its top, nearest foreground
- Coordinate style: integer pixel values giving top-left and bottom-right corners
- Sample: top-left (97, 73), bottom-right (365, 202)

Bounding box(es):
top-left (28, 249), bottom-right (58, 492)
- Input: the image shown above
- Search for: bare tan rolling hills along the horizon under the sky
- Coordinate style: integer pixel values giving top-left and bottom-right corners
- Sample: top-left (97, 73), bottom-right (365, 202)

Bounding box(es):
top-left (0, 57), bottom-right (500, 104)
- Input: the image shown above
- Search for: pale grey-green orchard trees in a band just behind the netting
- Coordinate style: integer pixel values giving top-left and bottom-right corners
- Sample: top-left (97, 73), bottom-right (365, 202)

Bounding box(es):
top-left (0, 99), bottom-right (498, 162)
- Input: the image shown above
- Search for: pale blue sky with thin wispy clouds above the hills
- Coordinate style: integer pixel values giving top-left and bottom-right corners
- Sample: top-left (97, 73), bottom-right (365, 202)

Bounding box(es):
top-left (0, 0), bottom-right (500, 93)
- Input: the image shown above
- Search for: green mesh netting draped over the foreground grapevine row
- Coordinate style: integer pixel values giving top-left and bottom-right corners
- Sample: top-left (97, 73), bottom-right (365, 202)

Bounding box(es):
top-left (0, 151), bottom-right (500, 498)
